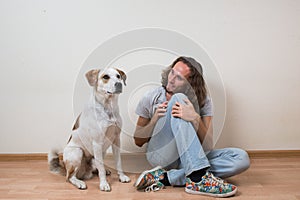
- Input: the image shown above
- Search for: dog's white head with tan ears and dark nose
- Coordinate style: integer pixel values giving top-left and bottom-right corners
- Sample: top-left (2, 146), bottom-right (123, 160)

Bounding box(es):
top-left (85, 68), bottom-right (126, 95)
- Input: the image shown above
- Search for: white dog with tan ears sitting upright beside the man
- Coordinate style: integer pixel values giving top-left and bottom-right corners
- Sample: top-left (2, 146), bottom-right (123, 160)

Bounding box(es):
top-left (48, 68), bottom-right (130, 191)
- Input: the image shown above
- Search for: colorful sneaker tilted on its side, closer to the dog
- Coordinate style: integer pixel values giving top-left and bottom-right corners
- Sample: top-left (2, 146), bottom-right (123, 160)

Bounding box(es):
top-left (134, 166), bottom-right (166, 192)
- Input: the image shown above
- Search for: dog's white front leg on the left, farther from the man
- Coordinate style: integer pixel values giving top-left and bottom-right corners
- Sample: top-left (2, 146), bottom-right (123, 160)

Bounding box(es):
top-left (93, 142), bottom-right (111, 192)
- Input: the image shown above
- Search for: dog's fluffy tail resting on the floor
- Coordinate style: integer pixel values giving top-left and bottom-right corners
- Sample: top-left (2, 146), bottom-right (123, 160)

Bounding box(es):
top-left (48, 149), bottom-right (66, 176)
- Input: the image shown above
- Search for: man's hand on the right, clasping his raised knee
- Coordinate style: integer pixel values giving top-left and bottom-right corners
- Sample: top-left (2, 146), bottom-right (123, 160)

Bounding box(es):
top-left (172, 99), bottom-right (199, 122)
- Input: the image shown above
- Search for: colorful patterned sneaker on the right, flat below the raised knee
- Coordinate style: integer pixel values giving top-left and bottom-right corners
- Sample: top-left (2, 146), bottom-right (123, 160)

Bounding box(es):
top-left (185, 172), bottom-right (237, 197)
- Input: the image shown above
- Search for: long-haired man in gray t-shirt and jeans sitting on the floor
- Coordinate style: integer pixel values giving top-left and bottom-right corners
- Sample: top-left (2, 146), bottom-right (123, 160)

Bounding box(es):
top-left (134, 56), bottom-right (250, 197)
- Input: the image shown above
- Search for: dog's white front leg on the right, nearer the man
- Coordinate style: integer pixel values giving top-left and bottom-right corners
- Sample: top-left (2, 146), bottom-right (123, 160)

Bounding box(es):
top-left (112, 135), bottom-right (130, 183)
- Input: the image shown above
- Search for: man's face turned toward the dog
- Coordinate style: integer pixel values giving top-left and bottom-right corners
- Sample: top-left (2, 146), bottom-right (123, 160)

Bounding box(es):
top-left (166, 61), bottom-right (190, 93)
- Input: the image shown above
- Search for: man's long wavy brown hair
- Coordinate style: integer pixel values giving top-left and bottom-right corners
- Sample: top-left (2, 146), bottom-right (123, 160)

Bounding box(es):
top-left (161, 56), bottom-right (207, 111)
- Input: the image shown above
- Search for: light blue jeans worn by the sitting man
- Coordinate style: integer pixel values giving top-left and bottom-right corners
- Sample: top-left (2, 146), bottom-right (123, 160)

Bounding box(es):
top-left (146, 94), bottom-right (250, 185)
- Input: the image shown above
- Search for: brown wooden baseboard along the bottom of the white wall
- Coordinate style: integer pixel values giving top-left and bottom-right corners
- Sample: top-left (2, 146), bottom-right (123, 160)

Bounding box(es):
top-left (0, 150), bottom-right (300, 161)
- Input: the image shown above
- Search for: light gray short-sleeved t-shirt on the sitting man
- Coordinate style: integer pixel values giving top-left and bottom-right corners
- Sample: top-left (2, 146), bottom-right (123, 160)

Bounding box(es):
top-left (135, 86), bottom-right (213, 119)
